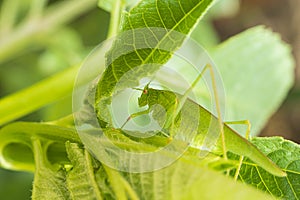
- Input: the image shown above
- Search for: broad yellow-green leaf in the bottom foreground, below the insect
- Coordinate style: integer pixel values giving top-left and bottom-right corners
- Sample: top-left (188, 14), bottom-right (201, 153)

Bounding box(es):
top-left (125, 156), bottom-right (272, 200)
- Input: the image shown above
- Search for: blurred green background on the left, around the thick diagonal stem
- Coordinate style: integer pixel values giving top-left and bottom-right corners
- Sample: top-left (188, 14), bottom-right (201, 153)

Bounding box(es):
top-left (0, 0), bottom-right (109, 200)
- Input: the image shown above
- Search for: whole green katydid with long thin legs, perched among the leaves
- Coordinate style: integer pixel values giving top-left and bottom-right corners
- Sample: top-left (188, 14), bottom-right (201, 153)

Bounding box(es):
top-left (121, 65), bottom-right (286, 179)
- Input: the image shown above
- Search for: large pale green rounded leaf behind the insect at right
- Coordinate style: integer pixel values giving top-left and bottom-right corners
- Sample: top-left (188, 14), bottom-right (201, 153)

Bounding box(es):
top-left (212, 26), bottom-right (295, 135)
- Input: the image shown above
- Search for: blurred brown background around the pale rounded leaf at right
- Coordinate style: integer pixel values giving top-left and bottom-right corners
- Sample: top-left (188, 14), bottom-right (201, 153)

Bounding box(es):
top-left (215, 0), bottom-right (300, 143)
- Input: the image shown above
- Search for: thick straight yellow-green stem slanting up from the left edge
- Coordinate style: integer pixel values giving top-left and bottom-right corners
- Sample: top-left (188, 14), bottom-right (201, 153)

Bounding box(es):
top-left (0, 32), bottom-right (107, 126)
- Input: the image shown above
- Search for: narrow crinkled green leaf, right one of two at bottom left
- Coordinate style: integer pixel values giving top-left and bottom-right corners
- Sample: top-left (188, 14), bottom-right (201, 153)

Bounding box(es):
top-left (66, 142), bottom-right (102, 199)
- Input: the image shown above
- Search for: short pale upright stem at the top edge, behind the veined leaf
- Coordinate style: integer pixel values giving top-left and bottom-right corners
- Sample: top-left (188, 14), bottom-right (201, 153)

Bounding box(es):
top-left (107, 0), bottom-right (125, 38)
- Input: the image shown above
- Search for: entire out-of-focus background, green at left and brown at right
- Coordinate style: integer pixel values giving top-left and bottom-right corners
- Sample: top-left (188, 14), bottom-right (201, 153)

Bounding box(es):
top-left (0, 0), bottom-right (300, 200)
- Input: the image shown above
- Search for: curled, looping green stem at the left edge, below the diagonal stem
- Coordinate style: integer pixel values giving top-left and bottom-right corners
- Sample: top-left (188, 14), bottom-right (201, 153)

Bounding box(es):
top-left (0, 122), bottom-right (80, 171)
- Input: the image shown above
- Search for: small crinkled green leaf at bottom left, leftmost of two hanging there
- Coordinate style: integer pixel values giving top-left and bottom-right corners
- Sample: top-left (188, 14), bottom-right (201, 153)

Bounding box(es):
top-left (32, 140), bottom-right (69, 200)
